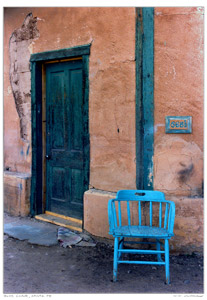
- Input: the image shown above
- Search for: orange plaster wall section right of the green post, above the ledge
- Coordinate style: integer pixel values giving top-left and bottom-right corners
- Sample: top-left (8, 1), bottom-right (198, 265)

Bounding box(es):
top-left (154, 7), bottom-right (204, 197)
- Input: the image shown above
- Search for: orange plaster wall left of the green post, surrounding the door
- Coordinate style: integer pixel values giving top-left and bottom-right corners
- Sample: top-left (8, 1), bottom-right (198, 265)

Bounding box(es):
top-left (4, 7), bottom-right (136, 191)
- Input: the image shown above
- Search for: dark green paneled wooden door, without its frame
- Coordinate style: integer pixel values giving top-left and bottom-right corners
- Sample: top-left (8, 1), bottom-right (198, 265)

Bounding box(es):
top-left (46, 60), bottom-right (87, 219)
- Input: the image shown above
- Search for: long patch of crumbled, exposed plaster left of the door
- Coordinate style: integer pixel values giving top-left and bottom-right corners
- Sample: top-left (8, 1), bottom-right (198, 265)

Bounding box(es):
top-left (9, 13), bottom-right (39, 142)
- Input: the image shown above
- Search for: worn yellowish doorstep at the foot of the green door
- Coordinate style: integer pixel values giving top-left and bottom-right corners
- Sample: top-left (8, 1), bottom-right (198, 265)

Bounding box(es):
top-left (35, 211), bottom-right (83, 232)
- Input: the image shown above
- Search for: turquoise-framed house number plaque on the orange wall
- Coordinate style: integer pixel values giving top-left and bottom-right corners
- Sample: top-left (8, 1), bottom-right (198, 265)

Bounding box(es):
top-left (165, 116), bottom-right (192, 133)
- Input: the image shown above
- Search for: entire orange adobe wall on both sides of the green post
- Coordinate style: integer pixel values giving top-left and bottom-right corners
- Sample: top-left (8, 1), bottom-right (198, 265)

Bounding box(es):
top-left (4, 7), bottom-right (204, 252)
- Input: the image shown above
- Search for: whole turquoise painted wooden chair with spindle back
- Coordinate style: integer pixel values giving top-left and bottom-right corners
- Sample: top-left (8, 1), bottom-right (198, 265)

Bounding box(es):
top-left (108, 190), bottom-right (175, 284)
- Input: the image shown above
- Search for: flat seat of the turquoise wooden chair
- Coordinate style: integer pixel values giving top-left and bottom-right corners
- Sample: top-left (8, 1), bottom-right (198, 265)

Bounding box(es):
top-left (113, 225), bottom-right (172, 238)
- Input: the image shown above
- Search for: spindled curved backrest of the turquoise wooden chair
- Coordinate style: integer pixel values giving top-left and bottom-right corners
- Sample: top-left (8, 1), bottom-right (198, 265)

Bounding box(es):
top-left (108, 190), bottom-right (175, 234)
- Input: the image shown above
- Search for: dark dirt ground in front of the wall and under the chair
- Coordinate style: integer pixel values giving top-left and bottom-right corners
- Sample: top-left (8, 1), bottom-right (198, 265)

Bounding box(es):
top-left (3, 236), bottom-right (204, 296)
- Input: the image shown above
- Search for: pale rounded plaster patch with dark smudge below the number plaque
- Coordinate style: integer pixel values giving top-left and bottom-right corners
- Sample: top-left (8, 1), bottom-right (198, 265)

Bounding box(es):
top-left (154, 136), bottom-right (203, 197)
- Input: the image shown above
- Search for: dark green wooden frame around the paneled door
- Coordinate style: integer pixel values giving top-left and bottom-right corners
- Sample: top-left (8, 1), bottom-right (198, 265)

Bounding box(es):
top-left (30, 44), bottom-right (91, 216)
